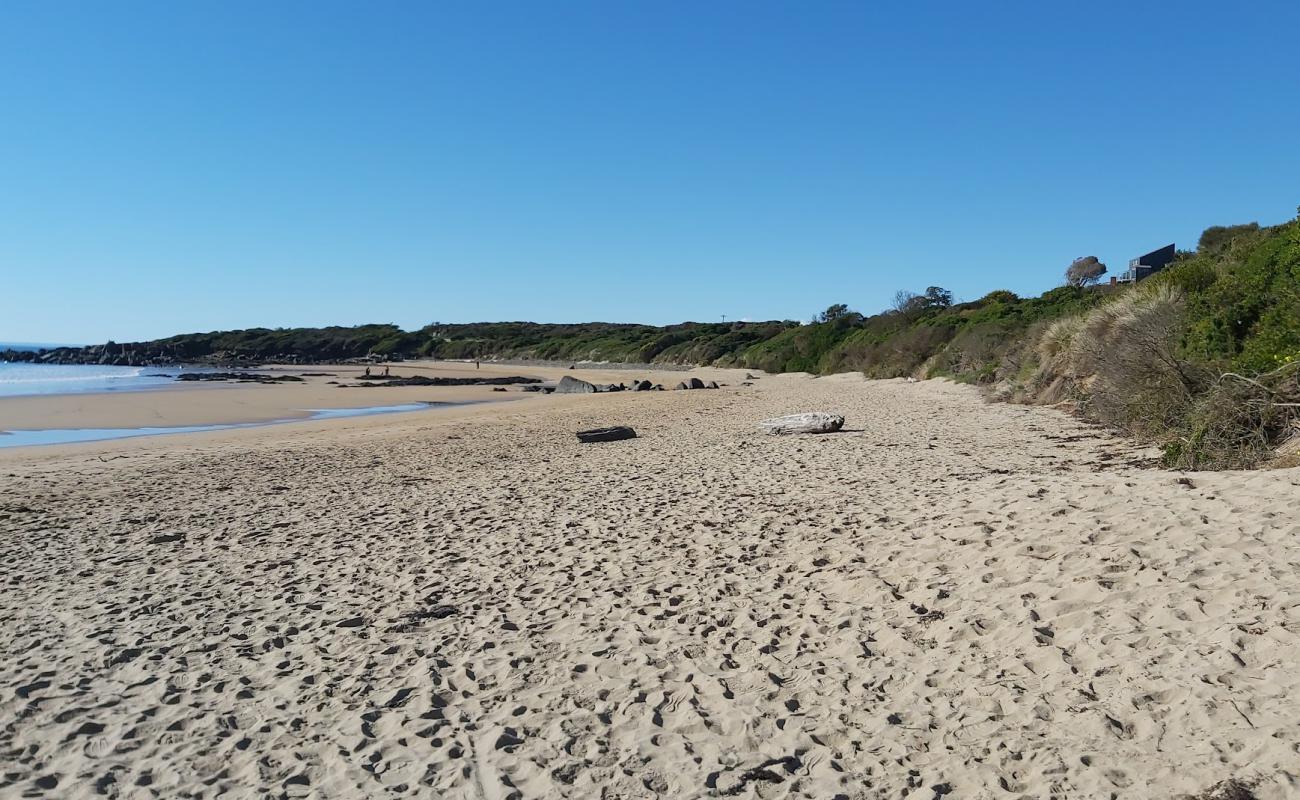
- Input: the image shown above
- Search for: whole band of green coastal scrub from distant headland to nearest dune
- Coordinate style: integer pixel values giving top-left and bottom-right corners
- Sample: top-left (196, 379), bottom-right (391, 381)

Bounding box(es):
top-left (0, 210), bottom-right (1300, 470)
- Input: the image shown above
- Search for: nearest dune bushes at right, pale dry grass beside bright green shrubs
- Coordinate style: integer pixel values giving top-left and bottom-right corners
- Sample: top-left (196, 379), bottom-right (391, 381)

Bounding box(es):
top-left (997, 219), bottom-right (1300, 470)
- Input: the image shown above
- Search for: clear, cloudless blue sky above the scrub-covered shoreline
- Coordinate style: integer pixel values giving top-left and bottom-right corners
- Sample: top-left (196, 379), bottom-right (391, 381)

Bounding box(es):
top-left (0, 0), bottom-right (1300, 342)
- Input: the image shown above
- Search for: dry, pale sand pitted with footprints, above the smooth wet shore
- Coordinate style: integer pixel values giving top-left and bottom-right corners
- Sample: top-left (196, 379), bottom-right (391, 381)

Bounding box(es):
top-left (0, 376), bottom-right (1300, 800)
